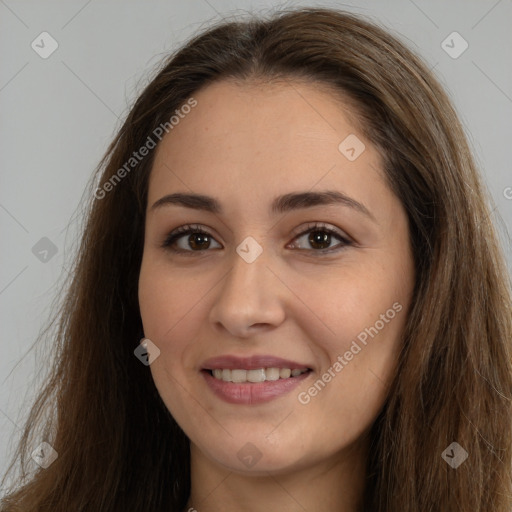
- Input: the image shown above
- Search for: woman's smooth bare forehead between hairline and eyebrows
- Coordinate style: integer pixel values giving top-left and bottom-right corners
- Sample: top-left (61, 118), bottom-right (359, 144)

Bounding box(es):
top-left (149, 81), bottom-right (385, 215)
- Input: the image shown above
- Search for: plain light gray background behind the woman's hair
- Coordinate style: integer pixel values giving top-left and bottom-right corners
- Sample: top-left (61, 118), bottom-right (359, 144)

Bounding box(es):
top-left (0, 0), bottom-right (512, 480)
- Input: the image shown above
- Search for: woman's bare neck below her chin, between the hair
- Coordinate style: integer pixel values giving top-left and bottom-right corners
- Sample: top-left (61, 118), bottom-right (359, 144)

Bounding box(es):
top-left (185, 436), bottom-right (367, 512)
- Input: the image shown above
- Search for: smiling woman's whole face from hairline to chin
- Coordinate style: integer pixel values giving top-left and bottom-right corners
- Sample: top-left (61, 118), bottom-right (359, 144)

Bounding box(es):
top-left (139, 81), bottom-right (414, 474)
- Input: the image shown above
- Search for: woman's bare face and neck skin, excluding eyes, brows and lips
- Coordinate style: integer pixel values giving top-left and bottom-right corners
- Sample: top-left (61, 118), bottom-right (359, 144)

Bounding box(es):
top-left (139, 81), bottom-right (414, 512)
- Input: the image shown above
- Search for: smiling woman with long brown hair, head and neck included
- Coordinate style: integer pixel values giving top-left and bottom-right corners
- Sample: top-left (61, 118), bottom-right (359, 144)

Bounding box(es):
top-left (2, 9), bottom-right (512, 512)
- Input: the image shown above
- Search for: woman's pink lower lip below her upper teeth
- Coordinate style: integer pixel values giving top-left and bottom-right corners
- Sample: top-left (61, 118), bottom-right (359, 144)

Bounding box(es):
top-left (201, 370), bottom-right (311, 405)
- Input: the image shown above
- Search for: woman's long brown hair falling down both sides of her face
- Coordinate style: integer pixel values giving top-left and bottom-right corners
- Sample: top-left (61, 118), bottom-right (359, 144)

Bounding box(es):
top-left (1, 8), bottom-right (512, 512)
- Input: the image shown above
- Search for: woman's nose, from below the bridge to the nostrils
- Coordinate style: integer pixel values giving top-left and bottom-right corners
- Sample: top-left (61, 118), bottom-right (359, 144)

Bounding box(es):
top-left (209, 246), bottom-right (285, 338)
